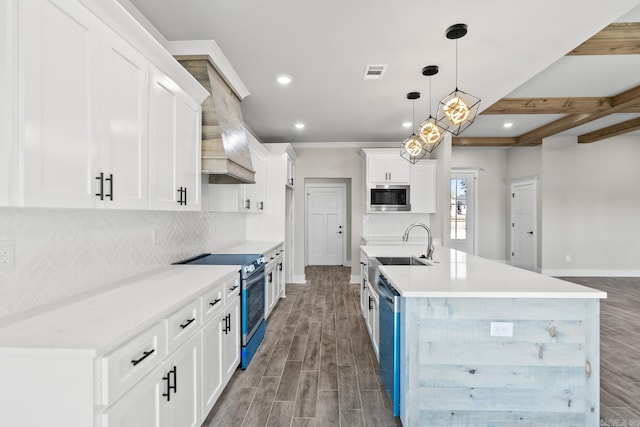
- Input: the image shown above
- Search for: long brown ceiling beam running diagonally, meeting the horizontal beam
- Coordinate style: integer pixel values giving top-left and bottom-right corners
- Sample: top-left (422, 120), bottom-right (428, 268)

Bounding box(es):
top-left (516, 86), bottom-right (640, 145)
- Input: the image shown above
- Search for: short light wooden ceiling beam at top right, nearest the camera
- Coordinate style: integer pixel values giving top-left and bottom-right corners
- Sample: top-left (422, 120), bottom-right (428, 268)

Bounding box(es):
top-left (567, 22), bottom-right (640, 55)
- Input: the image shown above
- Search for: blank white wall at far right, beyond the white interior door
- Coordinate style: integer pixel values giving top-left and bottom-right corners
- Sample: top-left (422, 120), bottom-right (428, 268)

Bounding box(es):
top-left (541, 136), bottom-right (640, 276)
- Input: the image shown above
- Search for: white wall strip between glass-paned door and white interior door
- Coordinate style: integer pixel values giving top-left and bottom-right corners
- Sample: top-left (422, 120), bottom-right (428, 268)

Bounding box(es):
top-left (451, 147), bottom-right (509, 261)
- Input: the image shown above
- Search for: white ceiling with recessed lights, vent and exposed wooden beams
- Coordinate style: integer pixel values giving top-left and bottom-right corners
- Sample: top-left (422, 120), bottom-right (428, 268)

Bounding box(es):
top-left (123, 0), bottom-right (640, 145)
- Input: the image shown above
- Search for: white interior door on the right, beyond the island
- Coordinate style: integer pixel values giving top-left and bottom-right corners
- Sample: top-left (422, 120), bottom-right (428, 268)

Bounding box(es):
top-left (511, 181), bottom-right (538, 271)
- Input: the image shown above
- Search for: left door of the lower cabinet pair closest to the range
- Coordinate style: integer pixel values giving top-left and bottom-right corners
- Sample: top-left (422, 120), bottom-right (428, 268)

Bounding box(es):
top-left (202, 312), bottom-right (227, 419)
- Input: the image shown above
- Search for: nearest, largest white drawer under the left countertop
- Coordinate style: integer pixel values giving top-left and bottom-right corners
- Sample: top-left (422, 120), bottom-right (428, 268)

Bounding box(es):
top-left (101, 323), bottom-right (166, 405)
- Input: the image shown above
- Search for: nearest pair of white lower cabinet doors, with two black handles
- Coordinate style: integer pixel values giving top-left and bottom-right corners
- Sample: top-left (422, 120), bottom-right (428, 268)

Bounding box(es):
top-left (102, 335), bottom-right (201, 427)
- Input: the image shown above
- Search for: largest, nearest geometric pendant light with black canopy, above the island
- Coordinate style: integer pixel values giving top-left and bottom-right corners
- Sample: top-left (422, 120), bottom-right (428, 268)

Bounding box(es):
top-left (436, 24), bottom-right (480, 135)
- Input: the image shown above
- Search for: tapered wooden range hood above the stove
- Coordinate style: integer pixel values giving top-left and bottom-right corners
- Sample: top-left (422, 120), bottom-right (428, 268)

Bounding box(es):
top-left (175, 55), bottom-right (255, 184)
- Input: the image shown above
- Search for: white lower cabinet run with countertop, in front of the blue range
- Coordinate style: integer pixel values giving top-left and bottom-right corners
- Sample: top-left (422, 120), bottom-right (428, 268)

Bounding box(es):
top-left (0, 266), bottom-right (241, 427)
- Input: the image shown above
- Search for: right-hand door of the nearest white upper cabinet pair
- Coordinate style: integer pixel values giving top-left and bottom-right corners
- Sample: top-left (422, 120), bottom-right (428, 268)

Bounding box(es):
top-left (100, 31), bottom-right (149, 209)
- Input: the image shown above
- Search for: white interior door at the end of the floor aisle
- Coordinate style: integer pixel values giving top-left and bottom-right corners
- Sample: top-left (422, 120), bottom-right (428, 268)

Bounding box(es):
top-left (306, 184), bottom-right (346, 265)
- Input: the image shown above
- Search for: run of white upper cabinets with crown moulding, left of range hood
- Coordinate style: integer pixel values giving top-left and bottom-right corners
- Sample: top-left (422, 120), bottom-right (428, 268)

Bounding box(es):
top-left (5, 0), bottom-right (207, 210)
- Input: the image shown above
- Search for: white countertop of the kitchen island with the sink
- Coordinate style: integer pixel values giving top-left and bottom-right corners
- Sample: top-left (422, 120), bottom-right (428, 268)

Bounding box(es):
top-left (360, 246), bottom-right (607, 298)
